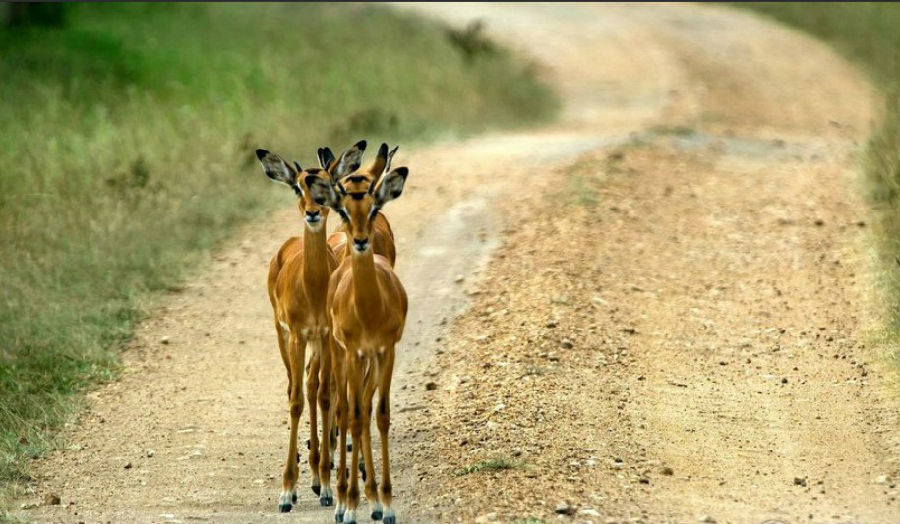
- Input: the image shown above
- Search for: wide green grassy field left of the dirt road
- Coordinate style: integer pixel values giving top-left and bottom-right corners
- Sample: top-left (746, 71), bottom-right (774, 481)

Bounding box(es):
top-left (0, 4), bottom-right (557, 520)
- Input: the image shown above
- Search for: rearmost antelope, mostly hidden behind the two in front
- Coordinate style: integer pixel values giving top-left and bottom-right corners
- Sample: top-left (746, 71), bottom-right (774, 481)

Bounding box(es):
top-left (318, 143), bottom-right (400, 267)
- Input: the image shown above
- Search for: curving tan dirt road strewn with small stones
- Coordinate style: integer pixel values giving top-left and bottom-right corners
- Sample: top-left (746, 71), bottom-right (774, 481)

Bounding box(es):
top-left (23, 4), bottom-right (900, 523)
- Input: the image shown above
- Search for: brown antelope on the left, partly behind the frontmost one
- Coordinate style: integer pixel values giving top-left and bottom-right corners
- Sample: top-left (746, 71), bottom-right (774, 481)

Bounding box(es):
top-left (256, 141), bottom-right (366, 513)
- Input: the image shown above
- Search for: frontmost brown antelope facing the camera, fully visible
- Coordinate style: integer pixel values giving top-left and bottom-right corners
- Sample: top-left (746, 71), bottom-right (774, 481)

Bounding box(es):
top-left (306, 162), bottom-right (408, 524)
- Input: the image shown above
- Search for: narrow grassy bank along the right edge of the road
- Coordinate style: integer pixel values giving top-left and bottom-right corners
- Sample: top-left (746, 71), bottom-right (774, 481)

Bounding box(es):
top-left (733, 2), bottom-right (900, 350)
